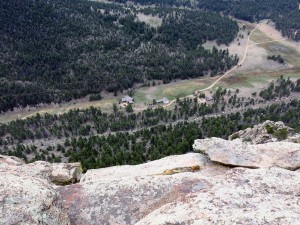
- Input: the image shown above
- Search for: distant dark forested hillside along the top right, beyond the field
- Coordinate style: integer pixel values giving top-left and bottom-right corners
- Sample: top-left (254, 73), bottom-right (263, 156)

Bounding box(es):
top-left (115, 0), bottom-right (300, 41)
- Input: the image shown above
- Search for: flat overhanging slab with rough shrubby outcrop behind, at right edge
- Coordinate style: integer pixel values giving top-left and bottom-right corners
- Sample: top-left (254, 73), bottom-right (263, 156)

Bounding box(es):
top-left (193, 121), bottom-right (300, 170)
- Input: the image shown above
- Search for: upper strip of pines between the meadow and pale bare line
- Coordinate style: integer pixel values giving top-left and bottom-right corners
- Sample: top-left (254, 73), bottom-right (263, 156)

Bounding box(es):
top-left (0, 78), bottom-right (300, 146)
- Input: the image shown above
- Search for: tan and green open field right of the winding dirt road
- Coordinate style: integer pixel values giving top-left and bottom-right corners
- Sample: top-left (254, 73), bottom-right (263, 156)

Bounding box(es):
top-left (218, 21), bottom-right (300, 89)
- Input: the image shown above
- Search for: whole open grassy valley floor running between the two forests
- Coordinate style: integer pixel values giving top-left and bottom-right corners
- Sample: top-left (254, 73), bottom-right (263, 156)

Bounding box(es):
top-left (0, 18), bottom-right (300, 123)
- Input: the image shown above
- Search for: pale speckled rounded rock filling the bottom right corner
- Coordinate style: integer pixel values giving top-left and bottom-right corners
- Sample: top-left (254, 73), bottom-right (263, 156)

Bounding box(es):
top-left (136, 168), bottom-right (300, 225)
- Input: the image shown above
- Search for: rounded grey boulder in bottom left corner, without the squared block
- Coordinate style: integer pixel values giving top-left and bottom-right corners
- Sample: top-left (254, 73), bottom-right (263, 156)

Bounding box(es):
top-left (0, 171), bottom-right (70, 225)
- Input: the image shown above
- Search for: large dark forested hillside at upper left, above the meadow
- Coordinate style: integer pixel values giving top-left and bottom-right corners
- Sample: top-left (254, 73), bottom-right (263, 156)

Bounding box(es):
top-left (0, 0), bottom-right (238, 112)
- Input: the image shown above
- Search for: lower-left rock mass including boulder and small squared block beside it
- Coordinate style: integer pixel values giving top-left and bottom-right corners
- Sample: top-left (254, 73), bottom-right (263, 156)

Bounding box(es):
top-left (0, 156), bottom-right (81, 225)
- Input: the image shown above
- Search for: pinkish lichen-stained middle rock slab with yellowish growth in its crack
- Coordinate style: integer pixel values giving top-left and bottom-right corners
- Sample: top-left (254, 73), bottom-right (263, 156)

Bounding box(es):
top-left (59, 153), bottom-right (220, 225)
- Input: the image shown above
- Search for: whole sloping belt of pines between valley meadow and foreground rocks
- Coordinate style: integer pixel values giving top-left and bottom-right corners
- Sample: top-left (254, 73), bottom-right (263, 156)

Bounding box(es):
top-left (0, 77), bottom-right (300, 169)
